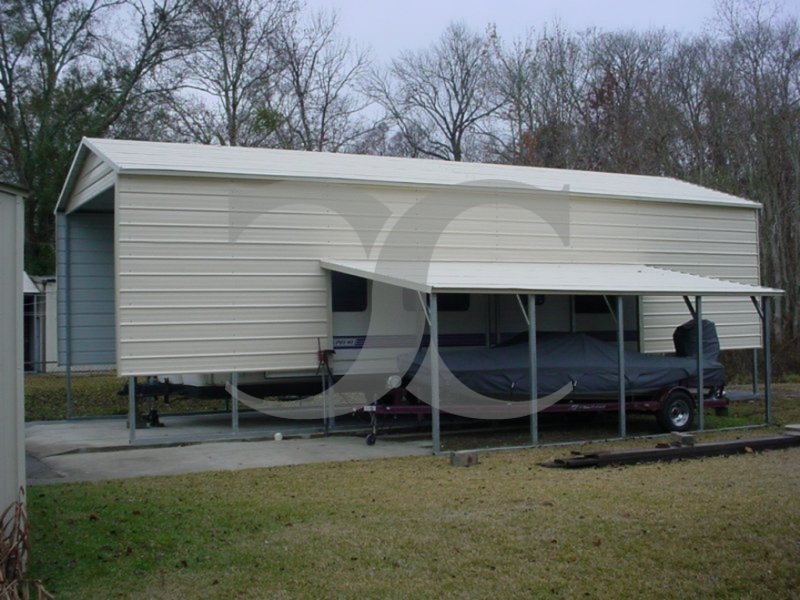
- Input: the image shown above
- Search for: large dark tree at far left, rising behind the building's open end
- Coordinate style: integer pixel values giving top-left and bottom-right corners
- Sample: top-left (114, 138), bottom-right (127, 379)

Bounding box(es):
top-left (0, 0), bottom-right (195, 273)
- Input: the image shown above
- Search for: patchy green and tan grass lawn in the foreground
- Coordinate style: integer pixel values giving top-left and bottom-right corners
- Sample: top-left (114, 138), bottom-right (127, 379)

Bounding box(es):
top-left (29, 448), bottom-right (800, 599)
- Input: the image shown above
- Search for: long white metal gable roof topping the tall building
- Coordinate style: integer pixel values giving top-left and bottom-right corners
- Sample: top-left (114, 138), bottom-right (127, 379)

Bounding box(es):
top-left (59, 138), bottom-right (760, 208)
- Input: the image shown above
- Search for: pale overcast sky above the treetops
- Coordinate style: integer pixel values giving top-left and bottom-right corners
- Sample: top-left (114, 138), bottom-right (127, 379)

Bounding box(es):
top-left (306, 0), bottom-right (800, 61)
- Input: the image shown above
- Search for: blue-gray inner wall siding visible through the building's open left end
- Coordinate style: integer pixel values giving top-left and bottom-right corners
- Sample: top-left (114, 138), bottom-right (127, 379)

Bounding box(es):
top-left (56, 212), bottom-right (116, 366)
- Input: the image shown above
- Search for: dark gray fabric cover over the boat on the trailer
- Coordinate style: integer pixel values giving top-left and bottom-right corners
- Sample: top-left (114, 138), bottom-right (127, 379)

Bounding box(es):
top-left (400, 333), bottom-right (725, 398)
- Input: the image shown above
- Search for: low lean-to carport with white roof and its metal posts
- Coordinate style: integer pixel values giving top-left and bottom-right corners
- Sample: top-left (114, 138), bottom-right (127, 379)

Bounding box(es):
top-left (320, 260), bottom-right (782, 453)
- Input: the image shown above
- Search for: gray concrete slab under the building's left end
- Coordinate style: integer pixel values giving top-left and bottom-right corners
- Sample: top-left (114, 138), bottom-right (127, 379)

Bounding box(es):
top-left (26, 414), bottom-right (431, 485)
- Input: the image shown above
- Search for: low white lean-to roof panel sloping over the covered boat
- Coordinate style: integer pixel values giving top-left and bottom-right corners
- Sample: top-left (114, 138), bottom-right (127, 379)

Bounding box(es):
top-left (320, 260), bottom-right (782, 296)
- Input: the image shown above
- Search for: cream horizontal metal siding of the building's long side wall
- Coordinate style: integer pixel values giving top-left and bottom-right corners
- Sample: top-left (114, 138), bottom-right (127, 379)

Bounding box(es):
top-left (114, 175), bottom-right (760, 375)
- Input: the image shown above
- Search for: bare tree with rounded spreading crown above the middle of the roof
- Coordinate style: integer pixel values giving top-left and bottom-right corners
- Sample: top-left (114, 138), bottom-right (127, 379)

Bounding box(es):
top-left (368, 23), bottom-right (504, 161)
